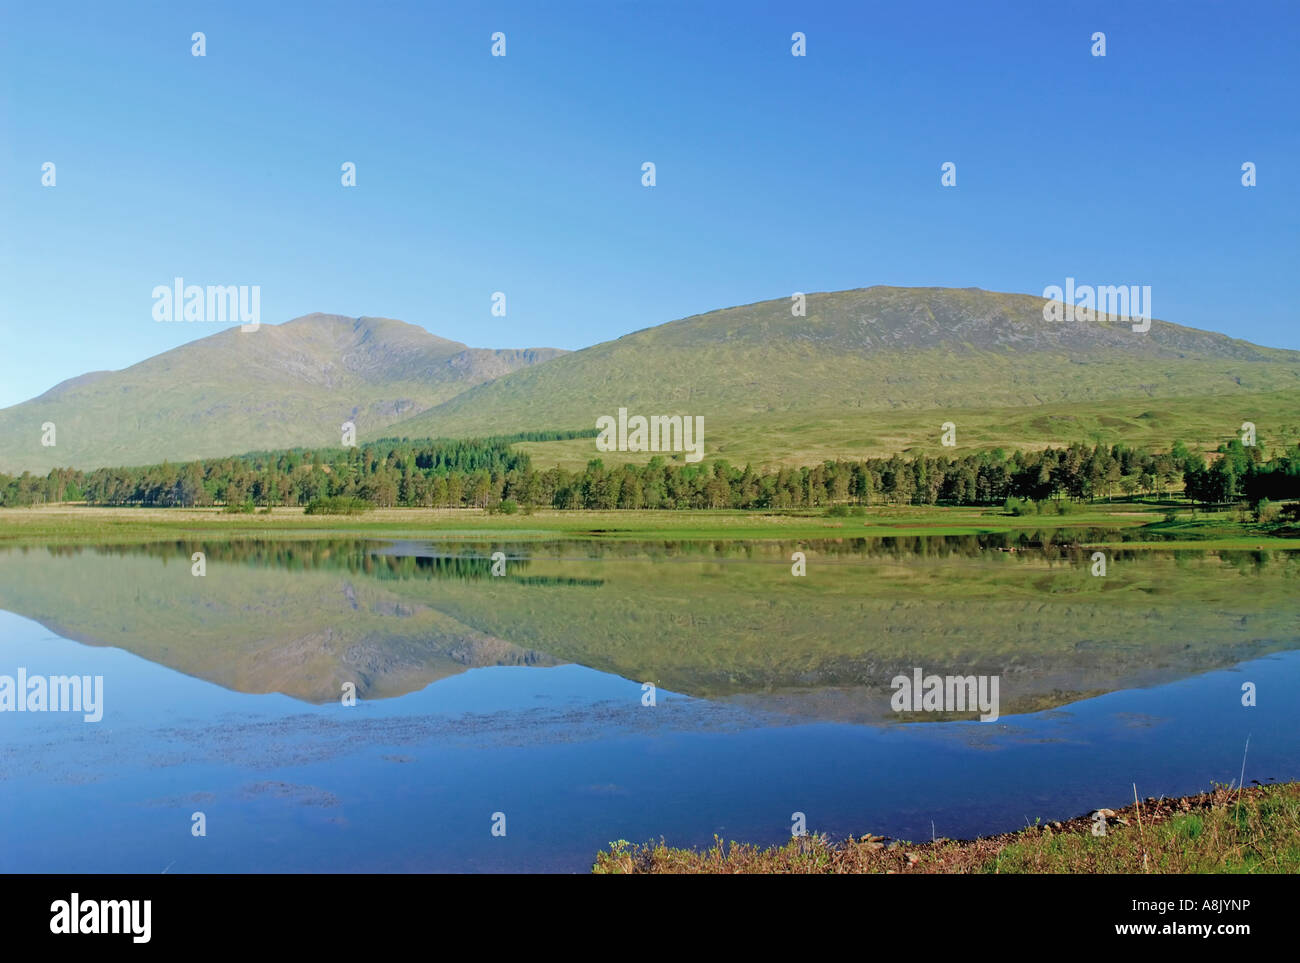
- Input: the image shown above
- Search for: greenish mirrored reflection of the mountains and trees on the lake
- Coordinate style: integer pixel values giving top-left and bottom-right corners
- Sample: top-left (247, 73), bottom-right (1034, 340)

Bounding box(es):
top-left (0, 532), bottom-right (1300, 721)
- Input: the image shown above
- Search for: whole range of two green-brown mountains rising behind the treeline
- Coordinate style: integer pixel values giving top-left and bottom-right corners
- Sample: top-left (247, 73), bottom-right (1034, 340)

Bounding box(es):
top-left (0, 287), bottom-right (1300, 472)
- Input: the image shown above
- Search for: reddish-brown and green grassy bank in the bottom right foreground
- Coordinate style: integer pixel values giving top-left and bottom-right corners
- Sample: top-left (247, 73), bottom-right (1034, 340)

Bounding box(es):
top-left (592, 782), bottom-right (1300, 875)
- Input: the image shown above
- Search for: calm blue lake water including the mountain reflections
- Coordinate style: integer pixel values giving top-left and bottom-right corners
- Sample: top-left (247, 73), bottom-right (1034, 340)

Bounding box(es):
top-left (0, 533), bottom-right (1300, 873)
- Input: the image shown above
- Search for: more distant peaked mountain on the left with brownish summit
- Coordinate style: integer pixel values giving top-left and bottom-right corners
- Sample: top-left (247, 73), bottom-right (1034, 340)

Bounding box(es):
top-left (0, 315), bottom-right (564, 473)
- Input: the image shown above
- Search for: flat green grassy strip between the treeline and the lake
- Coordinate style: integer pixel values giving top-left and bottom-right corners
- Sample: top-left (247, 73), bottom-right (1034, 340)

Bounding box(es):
top-left (0, 503), bottom-right (1300, 550)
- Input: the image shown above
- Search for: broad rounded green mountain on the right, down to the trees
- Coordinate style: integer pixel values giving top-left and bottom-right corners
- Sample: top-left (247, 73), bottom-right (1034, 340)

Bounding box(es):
top-left (385, 287), bottom-right (1300, 464)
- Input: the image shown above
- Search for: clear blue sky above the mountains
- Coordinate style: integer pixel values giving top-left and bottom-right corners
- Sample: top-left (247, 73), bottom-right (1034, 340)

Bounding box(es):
top-left (0, 0), bottom-right (1300, 405)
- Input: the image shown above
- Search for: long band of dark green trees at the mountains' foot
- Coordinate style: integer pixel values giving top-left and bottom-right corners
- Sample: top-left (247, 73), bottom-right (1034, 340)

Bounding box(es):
top-left (0, 431), bottom-right (1300, 512)
